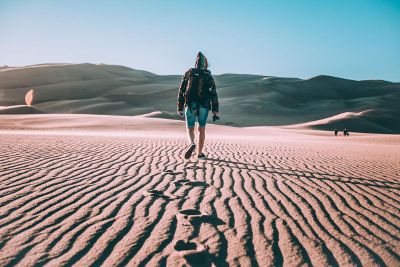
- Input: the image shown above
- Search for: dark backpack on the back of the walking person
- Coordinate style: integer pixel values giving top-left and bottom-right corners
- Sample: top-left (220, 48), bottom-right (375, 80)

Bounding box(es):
top-left (185, 68), bottom-right (210, 108)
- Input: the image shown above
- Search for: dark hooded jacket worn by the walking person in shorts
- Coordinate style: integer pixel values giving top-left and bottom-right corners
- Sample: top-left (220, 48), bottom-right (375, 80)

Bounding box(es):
top-left (177, 52), bottom-right (219, 112)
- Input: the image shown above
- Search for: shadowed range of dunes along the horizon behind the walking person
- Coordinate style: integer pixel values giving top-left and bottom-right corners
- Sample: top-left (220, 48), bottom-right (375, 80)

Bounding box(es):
top-left (0, 64), bottom-right (400, 134)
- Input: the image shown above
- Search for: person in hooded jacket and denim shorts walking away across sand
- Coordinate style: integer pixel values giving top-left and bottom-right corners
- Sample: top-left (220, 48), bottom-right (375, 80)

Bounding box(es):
top-left (177, 52), bottom-right (219, 159)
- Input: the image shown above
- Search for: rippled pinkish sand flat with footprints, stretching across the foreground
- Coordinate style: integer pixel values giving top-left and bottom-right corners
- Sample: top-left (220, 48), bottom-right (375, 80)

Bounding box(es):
top-left (0, 114), bottom-right (400, 266)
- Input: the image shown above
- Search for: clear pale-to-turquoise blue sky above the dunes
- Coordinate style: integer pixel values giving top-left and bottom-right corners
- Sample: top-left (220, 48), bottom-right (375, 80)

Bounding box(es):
top-left (0, 0), bottom-right (400, 81)
